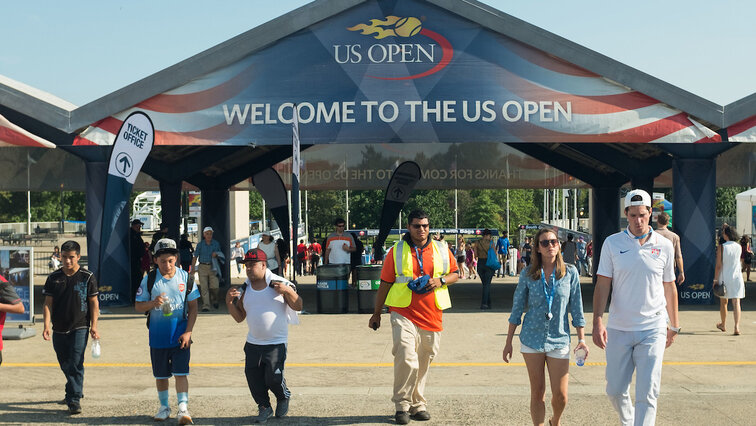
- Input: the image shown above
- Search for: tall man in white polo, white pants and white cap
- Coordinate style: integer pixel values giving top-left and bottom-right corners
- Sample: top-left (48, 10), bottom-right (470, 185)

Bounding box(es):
top-left (593, 189), bottom-right (680, 425)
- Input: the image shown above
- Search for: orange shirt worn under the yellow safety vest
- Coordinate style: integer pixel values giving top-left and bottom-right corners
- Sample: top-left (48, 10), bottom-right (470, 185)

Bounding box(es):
top-left (381, 244), bottom-right (458, 331)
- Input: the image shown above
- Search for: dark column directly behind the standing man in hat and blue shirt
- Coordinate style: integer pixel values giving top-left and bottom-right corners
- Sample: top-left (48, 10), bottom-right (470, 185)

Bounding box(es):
top-left (199, 189), bottom-right (231, 288)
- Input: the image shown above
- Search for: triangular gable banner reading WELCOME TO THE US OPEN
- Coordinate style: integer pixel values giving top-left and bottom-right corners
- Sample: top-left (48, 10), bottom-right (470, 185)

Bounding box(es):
top-left (74, 0), bottom-right (721, 145)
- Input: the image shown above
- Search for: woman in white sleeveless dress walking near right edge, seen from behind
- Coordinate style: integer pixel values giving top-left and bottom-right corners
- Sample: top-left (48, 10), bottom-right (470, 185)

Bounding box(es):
top-left (714, 224), bottom-right (745, 336)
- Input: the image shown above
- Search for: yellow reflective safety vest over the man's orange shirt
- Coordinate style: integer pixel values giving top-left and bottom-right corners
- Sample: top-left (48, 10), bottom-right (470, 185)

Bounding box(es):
top-left (386, 240), bottom-right (451, 310)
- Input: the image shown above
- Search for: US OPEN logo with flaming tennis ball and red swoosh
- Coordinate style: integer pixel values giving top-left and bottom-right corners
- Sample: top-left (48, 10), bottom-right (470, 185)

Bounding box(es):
top-left (333, 15), bottom-right (454, 80)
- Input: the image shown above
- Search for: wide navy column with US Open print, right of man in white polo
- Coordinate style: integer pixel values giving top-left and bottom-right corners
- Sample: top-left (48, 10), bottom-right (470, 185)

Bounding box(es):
top-left (672, 156), bottom-right (717, 304)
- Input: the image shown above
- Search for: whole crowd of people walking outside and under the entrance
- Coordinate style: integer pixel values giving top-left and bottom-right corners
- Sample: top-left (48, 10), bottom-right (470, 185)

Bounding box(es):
top-left (10, 190), bottom-right (753, 425)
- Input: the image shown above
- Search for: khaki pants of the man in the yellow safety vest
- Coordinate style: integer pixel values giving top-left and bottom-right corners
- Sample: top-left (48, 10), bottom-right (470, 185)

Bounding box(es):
top-left (391, 312), bottom-right (441, 414)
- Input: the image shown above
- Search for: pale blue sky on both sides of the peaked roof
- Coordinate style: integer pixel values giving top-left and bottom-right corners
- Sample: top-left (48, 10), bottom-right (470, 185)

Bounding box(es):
top-left (0, 0), bottom-right (756, 105)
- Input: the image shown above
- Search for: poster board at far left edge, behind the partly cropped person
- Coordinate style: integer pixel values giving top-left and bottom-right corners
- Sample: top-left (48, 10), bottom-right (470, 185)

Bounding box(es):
top-left (0, 247), bottom-right (34, 324)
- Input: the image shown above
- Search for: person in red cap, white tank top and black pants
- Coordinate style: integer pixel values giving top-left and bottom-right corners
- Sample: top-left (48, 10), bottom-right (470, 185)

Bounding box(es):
top-left (226, 249), bottom-right (303, 423)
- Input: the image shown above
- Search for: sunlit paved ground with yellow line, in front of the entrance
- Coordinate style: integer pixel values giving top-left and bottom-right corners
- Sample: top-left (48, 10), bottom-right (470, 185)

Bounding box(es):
top-left (0, 277), bottom-right (756, 425)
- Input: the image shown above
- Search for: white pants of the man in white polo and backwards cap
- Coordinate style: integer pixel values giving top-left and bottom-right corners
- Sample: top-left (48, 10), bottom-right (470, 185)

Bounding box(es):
top-left (606, 328), bottom-right (667, 426)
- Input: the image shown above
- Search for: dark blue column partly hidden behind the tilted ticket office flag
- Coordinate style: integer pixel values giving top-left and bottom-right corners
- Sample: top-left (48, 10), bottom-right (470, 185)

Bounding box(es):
top-left (84, 161), bottom-right (108, 283)
